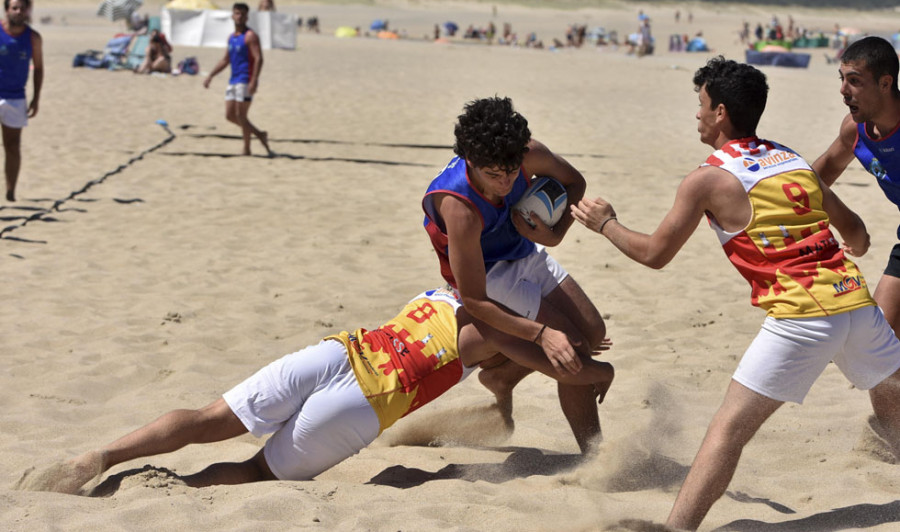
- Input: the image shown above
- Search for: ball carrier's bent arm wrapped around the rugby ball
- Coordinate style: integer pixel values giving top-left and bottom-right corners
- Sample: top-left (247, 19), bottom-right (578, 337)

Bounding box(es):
top-left (513, 139), bottom-right (586, 247)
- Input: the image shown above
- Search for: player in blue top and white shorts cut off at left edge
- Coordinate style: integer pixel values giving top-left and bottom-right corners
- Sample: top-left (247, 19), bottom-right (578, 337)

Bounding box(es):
top-left (0, 0), bottom-right (44, 201)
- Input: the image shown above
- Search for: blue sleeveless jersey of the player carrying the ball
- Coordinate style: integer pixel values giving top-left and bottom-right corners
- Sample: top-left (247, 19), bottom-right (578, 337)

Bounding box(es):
top-left (422, 157), bottom-right (536, 288)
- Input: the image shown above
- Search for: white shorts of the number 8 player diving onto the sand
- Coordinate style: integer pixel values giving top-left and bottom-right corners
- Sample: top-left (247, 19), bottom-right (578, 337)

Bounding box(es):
top-left (222, 340), bottom-right (381, 480)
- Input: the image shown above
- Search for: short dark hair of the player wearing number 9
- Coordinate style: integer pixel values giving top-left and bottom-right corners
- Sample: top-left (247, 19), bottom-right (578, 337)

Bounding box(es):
top-left (694, 55), bottom-right (769, 136)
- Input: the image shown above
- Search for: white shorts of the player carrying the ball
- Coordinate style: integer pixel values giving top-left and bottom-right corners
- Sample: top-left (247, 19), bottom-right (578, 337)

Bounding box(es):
top-left (485, 246), bottom-right (569, 320)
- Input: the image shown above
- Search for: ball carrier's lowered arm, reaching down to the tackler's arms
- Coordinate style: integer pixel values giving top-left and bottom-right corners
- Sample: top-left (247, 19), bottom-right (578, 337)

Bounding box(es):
top-left (437, 195), bottom-right (581, 373)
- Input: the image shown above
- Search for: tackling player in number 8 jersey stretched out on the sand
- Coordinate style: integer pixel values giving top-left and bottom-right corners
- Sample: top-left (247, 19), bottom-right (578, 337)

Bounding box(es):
top-left (16, 290), bottom-right (614, 494)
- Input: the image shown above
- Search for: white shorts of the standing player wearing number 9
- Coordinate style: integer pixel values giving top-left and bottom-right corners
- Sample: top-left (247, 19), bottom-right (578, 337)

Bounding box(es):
top-left (733, 306), bottom-right (900, 403)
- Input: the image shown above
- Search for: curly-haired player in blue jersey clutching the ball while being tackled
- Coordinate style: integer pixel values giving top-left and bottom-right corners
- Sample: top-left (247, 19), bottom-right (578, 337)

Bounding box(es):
top-left (422, 97), bottom-right (606, 451)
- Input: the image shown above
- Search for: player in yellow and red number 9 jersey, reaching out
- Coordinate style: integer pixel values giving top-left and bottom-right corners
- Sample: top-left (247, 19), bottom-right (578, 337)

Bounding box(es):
top-left (572, 56), bottom-right (900, 530)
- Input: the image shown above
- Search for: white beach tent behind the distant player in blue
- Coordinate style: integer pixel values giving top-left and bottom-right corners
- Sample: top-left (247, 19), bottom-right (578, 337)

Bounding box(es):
top-left (160, 0), bottom-right (297, 50)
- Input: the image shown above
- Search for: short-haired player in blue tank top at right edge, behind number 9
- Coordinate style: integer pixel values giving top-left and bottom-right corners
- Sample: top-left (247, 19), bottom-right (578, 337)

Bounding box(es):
top-left (812, 37), bottom-right (900, 340)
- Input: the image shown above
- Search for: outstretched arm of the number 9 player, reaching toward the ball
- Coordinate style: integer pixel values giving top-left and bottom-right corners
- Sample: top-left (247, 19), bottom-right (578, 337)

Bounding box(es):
top-left (572, 167), bottom-right (716, 269)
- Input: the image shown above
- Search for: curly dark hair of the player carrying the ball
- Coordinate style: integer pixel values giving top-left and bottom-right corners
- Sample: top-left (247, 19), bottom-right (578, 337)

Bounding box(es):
top-left (453, 96), bottom-right (531, 172)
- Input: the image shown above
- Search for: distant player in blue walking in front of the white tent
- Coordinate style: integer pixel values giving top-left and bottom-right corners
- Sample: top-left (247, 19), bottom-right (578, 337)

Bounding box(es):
top-left (203, 2), bottom-right (272, 155)
